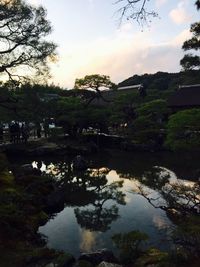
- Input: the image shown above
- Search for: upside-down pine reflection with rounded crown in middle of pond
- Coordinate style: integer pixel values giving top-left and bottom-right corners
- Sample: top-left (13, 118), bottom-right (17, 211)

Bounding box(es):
top-left (75, 169), bottom-right (125, 232)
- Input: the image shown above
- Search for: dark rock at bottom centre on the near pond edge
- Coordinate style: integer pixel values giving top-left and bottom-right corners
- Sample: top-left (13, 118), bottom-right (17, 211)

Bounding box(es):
top-left (79, 249), bottom-right (118, 265)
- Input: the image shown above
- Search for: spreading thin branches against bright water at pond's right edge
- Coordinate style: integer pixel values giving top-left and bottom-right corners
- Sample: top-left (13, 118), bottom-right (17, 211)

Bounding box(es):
top-left (133, 167), bottom-right (200, 216)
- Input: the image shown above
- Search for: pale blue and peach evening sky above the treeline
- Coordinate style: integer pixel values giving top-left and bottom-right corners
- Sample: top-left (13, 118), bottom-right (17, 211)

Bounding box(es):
top-left (27, 0), bottom-right (199, 89)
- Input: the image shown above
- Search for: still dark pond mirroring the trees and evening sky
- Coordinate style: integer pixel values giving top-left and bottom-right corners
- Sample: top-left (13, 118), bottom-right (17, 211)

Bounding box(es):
top-left (11, 151), bottom-right (200, 256)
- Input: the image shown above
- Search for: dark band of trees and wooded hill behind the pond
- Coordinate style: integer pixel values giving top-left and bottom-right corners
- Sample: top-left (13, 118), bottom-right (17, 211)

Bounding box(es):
top-left (0, 71), bottom-right (200, 153)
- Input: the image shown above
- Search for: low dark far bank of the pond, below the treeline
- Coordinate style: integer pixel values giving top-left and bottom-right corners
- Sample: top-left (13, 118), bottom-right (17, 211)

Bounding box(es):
top-left (0, 134), bottom-right (170, 160)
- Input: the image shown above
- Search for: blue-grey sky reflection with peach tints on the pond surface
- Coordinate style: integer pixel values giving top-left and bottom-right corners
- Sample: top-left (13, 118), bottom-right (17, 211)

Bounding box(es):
top-left (39, 166), bottom-right (171, 255)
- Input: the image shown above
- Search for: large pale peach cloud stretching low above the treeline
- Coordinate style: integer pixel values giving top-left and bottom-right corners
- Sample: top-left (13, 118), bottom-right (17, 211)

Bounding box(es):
top-left (49, 24), bottom-right (189, 88)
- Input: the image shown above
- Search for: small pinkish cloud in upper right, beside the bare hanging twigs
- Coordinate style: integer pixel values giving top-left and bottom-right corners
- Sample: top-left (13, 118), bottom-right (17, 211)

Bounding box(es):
top-left (169, 0), bottom-right (191, 24)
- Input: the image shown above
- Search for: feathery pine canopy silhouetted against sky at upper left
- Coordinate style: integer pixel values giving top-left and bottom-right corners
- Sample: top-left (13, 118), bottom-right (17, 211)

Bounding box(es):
top-left (0, 0), bottom-right (56, 84)
